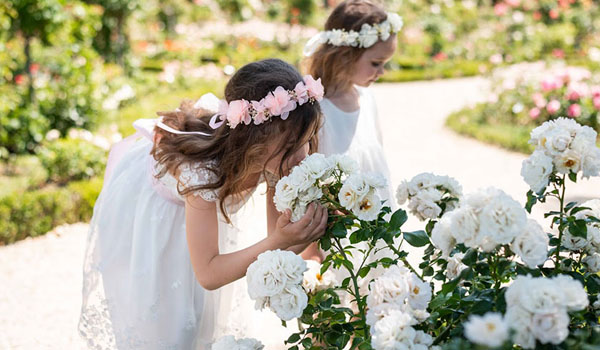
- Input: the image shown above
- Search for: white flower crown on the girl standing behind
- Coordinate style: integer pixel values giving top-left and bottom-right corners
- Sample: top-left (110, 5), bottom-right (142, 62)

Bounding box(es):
top-left (304, 13), bottom-right (404, 57)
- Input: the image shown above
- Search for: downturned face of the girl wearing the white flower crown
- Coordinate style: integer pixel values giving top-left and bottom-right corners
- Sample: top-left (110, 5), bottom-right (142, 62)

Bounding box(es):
top-left (352, 34), bottom-right (397, 87)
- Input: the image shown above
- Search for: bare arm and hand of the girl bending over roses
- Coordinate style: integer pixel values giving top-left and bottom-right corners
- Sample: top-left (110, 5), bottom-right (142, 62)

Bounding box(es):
top-left (185, 196), bottom-right (327, 290)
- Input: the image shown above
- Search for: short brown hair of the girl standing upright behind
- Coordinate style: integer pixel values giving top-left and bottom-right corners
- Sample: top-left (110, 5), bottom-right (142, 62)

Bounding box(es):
top-left (308, 0), bottom-right (387, 95)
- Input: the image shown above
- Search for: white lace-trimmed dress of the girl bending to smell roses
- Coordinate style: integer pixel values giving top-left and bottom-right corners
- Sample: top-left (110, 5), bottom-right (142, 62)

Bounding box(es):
top-left (79, 120), bottom-right (264, 350)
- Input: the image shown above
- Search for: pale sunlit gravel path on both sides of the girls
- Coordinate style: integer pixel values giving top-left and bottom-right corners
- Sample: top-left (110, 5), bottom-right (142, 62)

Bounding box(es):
top-left (0, 78), bottom-right (600, 350)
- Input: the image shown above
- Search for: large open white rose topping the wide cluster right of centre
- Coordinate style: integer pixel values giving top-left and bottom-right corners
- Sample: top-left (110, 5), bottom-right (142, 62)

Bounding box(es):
top-left (479, 190), bottom-right (527, 244)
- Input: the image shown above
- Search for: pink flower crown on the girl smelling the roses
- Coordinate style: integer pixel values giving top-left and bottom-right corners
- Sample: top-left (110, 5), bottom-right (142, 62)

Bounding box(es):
top-left (210, 75), bottom-right (324, 129)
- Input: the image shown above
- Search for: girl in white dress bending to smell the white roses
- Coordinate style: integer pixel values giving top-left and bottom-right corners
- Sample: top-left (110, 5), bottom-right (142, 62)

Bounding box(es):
top-left (79, 59), bottom-right (327, 350)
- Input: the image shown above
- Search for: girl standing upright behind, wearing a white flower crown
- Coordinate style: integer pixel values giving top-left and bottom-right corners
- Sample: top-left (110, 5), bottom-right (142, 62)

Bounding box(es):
top-left (304, 0), bottom-right (402, 208)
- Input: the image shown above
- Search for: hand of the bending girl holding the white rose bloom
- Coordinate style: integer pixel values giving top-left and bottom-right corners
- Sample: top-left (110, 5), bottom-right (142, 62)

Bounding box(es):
top-left (273, 203), bottom-right (328, 248)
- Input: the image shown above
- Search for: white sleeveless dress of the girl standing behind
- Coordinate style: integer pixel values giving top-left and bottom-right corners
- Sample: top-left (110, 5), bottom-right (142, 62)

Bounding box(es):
top-left (319, 86), bottom-right (397, 205)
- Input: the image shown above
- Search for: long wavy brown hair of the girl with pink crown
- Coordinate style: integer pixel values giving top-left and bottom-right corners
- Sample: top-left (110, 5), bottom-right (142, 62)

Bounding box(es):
top-left (152, 59), bottom-right (321, 221)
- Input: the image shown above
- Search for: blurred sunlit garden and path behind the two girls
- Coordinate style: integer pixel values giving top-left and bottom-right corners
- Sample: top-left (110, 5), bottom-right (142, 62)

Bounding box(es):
top-left (0, 0), bottom-right (600, 349)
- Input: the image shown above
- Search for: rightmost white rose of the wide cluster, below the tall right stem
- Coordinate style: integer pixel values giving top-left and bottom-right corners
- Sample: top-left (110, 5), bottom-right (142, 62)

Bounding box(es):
top-left (510, 219), bottom-right (550, 269)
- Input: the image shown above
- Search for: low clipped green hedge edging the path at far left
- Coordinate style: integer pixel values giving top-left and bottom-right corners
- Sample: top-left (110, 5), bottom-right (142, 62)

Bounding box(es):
top-left (0, 177), bottom-right (102, 245)
